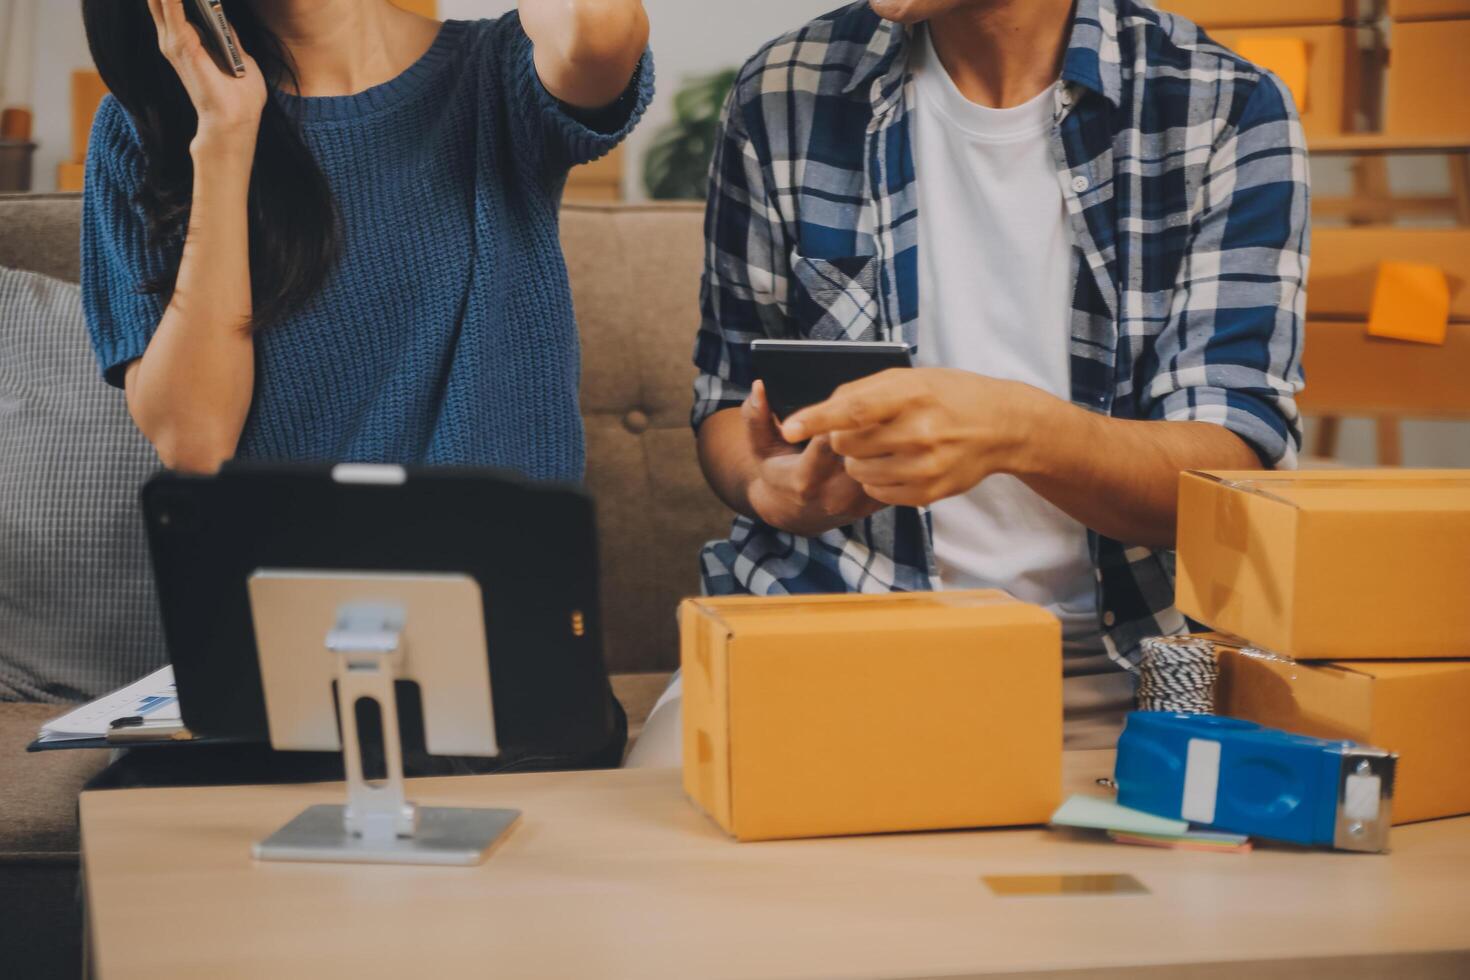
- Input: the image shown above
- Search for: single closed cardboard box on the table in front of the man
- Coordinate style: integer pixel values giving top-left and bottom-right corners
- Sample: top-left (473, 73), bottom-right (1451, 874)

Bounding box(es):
top-left (679, 592), bottom-right (1061, 840)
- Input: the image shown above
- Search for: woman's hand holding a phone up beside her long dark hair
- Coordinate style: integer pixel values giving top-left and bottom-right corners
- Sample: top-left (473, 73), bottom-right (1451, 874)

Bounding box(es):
top-left (148, 0), bottom-right (266, 162)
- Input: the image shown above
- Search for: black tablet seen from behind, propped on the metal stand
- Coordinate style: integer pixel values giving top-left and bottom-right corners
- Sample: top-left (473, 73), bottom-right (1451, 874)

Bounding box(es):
top-left (143, 464), bottom-right (620, 758)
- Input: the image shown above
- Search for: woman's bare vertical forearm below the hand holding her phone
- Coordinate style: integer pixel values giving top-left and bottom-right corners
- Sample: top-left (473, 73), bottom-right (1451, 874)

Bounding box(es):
top-left (126, 140), bottom-right (254, 473)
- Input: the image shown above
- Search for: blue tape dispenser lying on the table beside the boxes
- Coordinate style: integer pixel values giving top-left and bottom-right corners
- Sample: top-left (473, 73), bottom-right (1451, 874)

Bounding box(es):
top-left (1114, 711), bottom-right (1398, 852)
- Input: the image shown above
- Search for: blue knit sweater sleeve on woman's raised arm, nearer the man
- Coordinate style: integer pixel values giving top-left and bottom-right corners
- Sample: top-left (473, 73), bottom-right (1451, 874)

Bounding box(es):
top-left (494, 13), bottom-right (654, 173)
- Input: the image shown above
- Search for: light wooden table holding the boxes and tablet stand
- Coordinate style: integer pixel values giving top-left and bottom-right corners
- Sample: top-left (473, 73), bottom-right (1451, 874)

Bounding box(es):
top-left (80, 752), bottom-right (1470, 980)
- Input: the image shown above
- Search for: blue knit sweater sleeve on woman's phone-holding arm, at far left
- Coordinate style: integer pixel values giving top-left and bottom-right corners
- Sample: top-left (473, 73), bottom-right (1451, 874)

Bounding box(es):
top-left (81, 96), bottom-right (168, 388)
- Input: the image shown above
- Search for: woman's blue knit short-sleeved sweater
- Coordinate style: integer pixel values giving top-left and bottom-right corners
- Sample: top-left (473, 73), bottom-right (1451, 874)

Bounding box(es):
top-left (82, 15), bottom-right (653, 480)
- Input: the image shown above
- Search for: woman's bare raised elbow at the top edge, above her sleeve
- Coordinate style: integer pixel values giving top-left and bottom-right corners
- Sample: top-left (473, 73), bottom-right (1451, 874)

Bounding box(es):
top-left (519, 0), bottom-right (648, 109)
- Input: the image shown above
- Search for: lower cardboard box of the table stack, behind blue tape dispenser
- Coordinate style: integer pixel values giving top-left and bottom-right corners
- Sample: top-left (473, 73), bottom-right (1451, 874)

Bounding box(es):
top-left (1216, 646), bottom-right (1470, 824)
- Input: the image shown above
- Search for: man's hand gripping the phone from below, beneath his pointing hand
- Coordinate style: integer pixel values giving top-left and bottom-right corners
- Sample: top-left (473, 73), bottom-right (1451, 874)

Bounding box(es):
top-left (700, 381), bottom-right (883, 538)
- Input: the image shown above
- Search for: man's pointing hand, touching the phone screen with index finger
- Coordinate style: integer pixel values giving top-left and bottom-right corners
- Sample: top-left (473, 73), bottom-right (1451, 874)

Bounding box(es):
top-left (782, 367), bottom-right (1057, 507)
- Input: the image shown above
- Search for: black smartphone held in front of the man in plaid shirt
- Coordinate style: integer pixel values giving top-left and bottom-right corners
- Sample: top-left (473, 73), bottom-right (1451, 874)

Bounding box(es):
top-left (750, 341), bottom-right (913, 420)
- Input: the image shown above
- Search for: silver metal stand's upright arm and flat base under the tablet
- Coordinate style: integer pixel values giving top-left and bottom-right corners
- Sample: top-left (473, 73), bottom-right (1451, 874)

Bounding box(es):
top-left (254, 602), bottom-right (520, 864)
